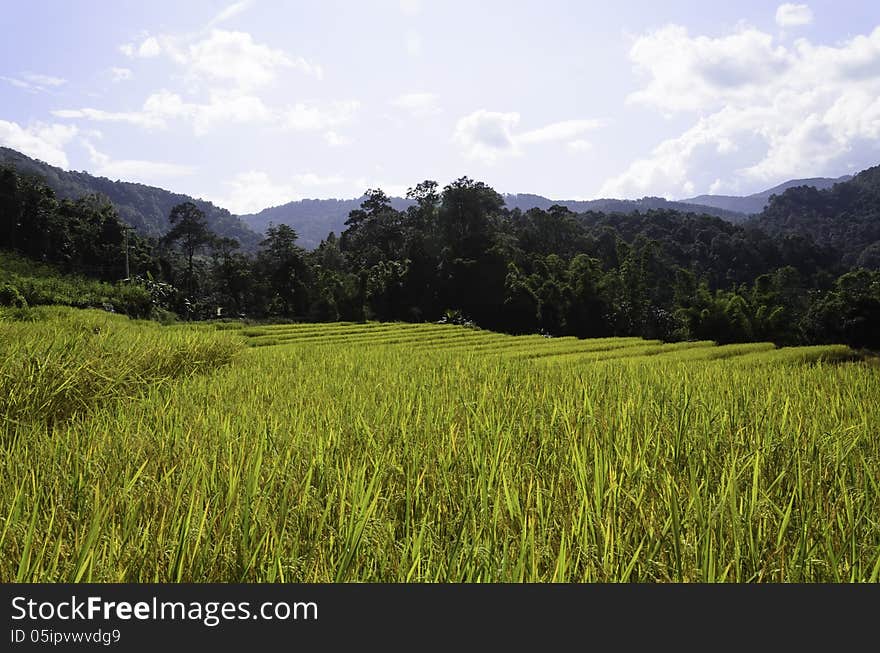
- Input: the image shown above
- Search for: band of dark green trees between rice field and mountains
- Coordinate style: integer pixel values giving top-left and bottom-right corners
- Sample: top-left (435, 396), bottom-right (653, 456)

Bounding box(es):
top-left (0, 168), bottom-right (880, 349)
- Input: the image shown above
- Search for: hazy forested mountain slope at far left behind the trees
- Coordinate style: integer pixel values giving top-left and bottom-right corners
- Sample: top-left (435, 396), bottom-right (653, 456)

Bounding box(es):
top-left (0, 147), bottom-right (262, 250)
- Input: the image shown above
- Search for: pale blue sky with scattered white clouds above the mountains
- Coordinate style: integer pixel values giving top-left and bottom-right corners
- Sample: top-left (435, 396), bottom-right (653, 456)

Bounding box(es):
top-left (0, 0), bottom-right (880, 213)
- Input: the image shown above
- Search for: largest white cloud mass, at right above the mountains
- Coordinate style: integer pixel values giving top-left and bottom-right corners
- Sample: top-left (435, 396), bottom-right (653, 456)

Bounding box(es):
top-left (599, 26), bottom-right (880, 197)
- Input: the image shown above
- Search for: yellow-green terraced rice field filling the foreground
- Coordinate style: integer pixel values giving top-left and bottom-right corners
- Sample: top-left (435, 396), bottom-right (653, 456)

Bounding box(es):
top-left (0, 309), bottom-right (880, 582)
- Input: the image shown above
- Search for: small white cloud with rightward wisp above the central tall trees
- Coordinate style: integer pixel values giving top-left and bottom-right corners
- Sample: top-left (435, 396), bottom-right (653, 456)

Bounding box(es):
top-left (453, 109), bottom-right (603, 163)
